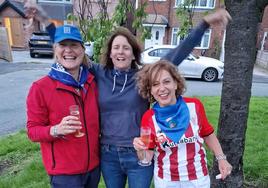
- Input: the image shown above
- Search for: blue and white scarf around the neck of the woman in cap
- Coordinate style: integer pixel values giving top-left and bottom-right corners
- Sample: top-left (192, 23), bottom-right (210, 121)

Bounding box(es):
top-left (48, 63), bottom-right (89, 88)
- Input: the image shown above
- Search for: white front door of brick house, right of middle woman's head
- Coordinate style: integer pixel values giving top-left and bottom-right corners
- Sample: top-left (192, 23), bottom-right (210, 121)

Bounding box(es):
top-left (144, 27), bottom-right (165, 49)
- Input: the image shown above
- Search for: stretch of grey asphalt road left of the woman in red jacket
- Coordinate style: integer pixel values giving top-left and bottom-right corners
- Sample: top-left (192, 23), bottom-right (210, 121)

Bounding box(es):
top-left (0, 63), bottom-right (50, 136)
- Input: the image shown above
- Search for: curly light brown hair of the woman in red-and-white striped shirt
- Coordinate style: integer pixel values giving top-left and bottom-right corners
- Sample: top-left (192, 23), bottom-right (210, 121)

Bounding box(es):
top-left (136, 60), bottom-right (186, 102)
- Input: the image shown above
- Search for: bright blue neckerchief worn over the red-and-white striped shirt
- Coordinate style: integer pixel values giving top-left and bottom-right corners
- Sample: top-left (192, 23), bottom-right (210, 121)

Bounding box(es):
top-left (153, 96), bottom-right (190, 143)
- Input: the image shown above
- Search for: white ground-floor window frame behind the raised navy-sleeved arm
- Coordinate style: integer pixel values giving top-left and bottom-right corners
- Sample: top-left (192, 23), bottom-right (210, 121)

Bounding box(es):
top-left (170, 27), bottom-right (212, 49)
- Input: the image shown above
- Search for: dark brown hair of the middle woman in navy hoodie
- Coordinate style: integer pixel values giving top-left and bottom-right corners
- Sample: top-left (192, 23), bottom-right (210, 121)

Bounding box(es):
top-left (100, 27), bottom-right (142, 69)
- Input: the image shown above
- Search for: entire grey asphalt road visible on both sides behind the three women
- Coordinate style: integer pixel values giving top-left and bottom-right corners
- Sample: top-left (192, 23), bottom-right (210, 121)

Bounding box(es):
top-left (0, 52), bottom-right (268, 136)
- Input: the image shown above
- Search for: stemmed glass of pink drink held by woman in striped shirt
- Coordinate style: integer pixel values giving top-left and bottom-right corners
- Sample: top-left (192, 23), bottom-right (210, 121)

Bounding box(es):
top-left (138, 127), bottom-right (152, 166)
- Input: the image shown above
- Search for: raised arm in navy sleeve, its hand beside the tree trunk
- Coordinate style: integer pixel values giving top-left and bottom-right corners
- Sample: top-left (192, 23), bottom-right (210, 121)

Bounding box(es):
top-left (162, 9), bottom-right (231, 65)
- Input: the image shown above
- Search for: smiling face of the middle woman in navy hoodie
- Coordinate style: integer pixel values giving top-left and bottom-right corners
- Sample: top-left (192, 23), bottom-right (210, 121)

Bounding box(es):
top-left (110, 35), bottom-right (135, 70)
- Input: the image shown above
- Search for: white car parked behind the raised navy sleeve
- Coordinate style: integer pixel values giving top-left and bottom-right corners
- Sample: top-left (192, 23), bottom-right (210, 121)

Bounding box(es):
top-left (141, 45), bottom-right (224, 82)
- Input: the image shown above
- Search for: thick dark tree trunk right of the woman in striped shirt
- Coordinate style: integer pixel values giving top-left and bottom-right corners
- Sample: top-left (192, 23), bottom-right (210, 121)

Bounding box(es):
top-left (211, 0), bottom-right (264, 188)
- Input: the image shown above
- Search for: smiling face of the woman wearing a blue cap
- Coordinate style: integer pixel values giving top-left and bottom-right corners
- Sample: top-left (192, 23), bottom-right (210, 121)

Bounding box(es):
top-left (54, 40), bottom-right (85, 75)
